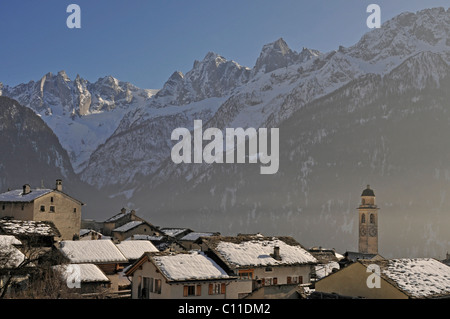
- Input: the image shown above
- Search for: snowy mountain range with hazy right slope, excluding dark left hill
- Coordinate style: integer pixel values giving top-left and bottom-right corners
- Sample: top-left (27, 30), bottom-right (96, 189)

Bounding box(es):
top-left (0, 8), bottom-right (450, 257)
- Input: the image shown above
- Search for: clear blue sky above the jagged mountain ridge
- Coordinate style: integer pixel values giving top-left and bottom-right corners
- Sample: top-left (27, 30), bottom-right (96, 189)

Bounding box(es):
top-left (0, 0), bottom-right (449, 89)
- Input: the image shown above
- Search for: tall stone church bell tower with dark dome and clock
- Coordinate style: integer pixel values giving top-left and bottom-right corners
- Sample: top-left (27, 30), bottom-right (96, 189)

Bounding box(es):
top-left (358, 185), bottom-right (379, 254)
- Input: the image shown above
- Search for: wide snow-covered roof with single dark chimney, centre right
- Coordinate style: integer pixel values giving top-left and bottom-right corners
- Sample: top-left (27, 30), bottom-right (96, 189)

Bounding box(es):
top-left (206, 236), bottom-right (317, 267)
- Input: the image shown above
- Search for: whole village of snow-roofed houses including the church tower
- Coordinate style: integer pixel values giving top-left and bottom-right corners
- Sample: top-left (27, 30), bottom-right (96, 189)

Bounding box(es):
top-left (0, 180), bottom-right (450, 300)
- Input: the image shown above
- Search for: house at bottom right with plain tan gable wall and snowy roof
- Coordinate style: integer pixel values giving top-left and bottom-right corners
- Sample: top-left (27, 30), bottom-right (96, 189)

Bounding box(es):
top-left (315, 258), bottom-right (450, 299)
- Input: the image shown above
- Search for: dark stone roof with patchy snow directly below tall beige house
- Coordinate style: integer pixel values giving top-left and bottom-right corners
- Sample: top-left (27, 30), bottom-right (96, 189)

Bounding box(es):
top-left (0, 220), bottom-right (60, 236)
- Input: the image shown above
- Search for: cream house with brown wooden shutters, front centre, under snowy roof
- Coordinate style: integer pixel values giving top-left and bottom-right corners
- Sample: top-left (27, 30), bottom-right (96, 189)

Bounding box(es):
top-left (126, 251), bottom-right (239, 299)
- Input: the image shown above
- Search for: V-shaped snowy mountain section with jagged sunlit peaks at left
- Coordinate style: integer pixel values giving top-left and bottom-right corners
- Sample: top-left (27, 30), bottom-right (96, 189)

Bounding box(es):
top-left (0, 71), bottom-right (157, 172)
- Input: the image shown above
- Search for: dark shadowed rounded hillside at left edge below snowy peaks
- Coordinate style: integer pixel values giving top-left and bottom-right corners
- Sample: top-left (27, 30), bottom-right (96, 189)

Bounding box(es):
top-left (0, 97), bottom-right (78, 191)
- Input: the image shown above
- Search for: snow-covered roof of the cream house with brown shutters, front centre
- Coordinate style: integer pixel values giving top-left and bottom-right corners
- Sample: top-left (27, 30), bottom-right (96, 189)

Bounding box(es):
top-left (150, 251), bottom-right (230, 281)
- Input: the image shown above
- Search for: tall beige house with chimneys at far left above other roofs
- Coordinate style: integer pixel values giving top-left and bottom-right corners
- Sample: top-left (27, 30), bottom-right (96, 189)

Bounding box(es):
top-left (0, 179), bottom-right (84, 240)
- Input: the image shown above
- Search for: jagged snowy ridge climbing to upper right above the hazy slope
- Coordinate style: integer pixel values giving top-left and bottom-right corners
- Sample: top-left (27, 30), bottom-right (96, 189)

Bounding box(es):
top-left (81, 9), bottom-right (450, 194)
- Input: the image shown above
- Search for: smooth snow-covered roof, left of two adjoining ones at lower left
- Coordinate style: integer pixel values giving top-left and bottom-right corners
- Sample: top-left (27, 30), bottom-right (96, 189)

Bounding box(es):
top-left (59, 240), bottom-right (128, 264)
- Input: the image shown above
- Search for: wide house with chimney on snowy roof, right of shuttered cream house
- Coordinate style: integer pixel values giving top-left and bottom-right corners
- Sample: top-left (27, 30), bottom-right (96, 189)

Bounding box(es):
top-left (201, 235), bottom-right (317, 298)
